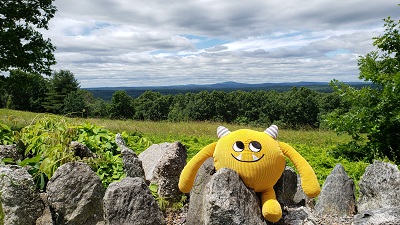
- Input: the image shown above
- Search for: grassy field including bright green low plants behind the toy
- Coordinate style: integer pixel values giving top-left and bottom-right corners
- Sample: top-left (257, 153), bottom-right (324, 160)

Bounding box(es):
top-left (0, 109), bottom-right (368, 192)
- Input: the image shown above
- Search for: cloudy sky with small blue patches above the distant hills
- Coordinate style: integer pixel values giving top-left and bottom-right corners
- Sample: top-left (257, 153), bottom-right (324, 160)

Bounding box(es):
top-left (43, 0), bottom-right (400, 88)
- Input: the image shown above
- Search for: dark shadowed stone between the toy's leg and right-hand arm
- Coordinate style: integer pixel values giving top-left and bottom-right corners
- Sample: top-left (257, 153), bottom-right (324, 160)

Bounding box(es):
top-left (274, 166), bottom-right (298, 206)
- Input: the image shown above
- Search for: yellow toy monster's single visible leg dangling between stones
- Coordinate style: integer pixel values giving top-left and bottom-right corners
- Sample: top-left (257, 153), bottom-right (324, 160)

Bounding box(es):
top-left (261, 188), bottom-right (282, 222)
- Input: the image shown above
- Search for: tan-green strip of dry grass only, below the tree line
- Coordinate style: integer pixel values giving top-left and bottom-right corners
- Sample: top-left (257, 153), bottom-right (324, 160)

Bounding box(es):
top-left (0, 109), bottom-right (349, 144)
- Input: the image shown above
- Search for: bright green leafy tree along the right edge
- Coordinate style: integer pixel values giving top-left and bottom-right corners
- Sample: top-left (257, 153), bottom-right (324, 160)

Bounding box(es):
top-left (327, 17), bottom-right (400, 162)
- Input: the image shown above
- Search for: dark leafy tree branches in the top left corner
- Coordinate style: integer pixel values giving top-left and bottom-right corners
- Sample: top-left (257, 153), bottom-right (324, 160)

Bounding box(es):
top-left (0, 0), bottom-right (57, 75)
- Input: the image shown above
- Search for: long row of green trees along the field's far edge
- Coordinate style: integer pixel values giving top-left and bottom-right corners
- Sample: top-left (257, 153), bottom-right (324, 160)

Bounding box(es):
top-left (0, 70), bottom-right (345, 128)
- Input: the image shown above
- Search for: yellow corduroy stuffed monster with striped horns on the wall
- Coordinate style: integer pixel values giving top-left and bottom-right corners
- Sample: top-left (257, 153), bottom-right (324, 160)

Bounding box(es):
top-left (179, 125), bottom-right (320, 222)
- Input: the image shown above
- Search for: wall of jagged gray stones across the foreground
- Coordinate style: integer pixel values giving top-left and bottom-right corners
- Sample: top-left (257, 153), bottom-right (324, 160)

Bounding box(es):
top-left (0, 139), bottom-right (400, 225)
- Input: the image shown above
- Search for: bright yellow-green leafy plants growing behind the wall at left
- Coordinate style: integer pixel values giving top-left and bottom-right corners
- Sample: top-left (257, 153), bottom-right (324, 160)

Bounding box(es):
top-left (0, 116), bottom-right (151, 190)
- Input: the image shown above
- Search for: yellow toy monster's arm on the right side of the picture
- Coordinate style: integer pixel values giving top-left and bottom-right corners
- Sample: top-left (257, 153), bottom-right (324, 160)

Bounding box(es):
top-left (279, 142), bottom-right (321, 197)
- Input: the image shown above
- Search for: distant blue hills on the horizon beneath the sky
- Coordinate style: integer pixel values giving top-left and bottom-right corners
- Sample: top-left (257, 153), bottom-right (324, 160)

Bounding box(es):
top-left (84, 82), bottom-right (371, 101)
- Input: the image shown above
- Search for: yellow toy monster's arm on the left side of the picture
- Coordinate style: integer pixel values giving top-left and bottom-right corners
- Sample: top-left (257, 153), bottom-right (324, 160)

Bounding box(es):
top-left (178, 142), bottom-right (217, 193)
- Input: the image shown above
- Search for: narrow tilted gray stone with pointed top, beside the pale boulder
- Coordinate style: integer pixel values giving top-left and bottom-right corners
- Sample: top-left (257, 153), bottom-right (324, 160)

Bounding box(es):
top-left (115, 133), bottom-right (145, 178)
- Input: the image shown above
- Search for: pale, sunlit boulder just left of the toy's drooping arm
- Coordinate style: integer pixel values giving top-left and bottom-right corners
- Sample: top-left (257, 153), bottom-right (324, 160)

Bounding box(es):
top-left (139, 142), bottom-right (187, 199)
